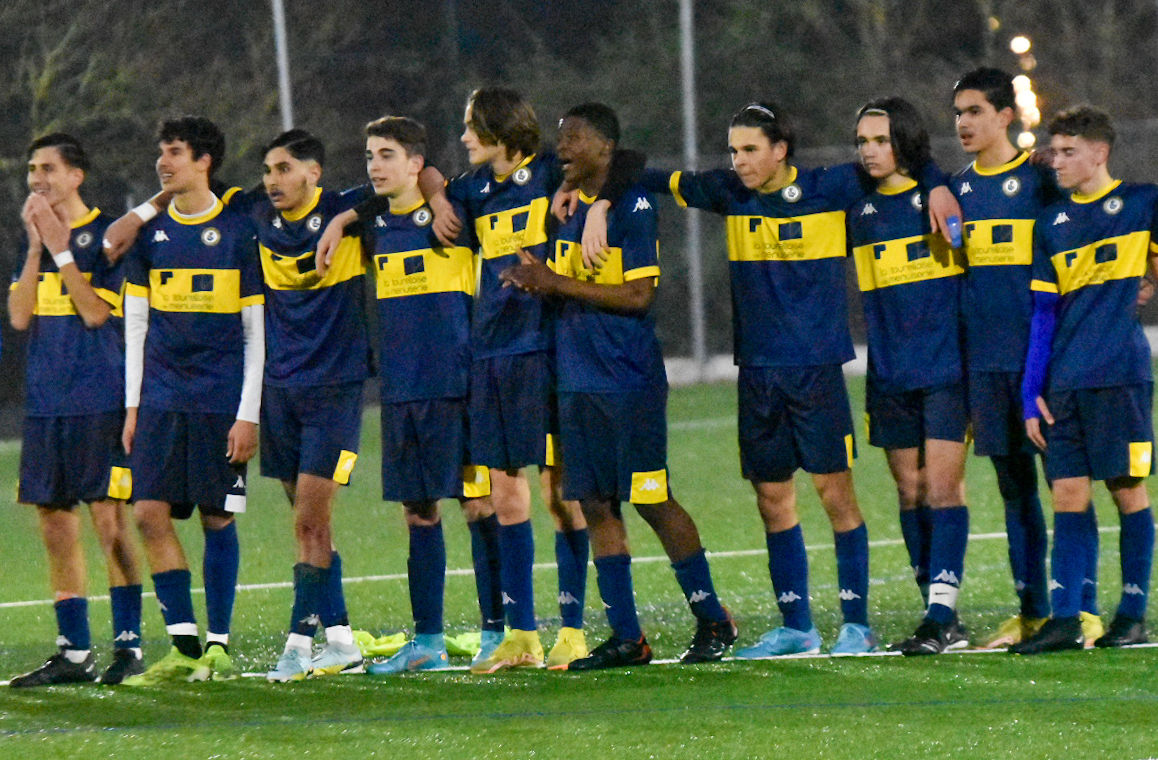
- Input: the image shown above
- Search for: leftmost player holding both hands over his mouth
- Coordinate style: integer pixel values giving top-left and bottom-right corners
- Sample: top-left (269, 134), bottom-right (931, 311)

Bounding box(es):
top-left (8, 132), bottom-right (145, 687)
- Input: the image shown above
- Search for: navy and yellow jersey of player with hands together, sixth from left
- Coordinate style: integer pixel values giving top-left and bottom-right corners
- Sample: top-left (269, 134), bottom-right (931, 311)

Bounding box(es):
top-left (551, 187), bottom-right (667, 393)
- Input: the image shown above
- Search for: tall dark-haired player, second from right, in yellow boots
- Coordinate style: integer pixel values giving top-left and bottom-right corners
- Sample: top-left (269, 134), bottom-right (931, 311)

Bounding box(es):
top-left (949, 68), bottom-right (1102, 648)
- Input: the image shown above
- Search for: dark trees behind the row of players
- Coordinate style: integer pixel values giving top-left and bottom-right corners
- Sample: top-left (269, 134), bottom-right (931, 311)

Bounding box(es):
top-left (0, 0), bottom-right (1158, 414)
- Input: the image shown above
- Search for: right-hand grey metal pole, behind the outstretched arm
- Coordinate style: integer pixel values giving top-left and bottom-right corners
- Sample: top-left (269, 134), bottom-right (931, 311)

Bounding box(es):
top-left (680, 0), bottom-right (708, 379)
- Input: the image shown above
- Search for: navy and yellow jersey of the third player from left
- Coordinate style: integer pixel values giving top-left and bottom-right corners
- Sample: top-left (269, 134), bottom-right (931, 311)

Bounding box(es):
top-left (229, 187), bottom-right (369, 387)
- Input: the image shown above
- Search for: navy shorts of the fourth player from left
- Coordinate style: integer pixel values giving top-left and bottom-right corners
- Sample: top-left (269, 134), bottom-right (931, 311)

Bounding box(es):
top-left (382, 399), bottom-right (474, 502)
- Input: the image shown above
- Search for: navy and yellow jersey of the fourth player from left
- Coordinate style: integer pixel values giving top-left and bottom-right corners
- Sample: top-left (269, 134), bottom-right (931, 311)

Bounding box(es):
top-left (366, 204), bottom-right (475, 403)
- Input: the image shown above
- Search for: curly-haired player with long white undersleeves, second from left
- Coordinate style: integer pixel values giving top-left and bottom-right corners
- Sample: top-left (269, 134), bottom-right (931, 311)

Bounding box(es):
top-left (123, 116), bottom-right (265, 686)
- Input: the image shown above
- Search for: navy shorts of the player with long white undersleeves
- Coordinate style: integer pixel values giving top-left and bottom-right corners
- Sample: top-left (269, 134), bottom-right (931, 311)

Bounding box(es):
top-left (130, 407), bottom-right (247, 520)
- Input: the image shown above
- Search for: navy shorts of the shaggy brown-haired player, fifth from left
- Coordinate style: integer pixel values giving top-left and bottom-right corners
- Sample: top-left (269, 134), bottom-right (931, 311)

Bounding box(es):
top-left (470, 351), bottom-right (551, 470)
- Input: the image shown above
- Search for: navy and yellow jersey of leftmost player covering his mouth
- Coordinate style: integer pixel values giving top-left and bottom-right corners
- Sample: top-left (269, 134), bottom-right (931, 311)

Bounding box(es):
top-left (13, 209), bottom-right (125, 417)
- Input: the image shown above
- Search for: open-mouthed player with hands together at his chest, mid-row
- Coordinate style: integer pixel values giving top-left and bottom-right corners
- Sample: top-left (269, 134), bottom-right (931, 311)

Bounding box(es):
top-left (503, 103), bottom-right (736, 671)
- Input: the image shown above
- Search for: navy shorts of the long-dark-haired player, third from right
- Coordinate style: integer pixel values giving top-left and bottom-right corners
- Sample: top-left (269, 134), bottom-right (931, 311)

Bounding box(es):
top-left (865, 378), bottom-right (969, 448)
